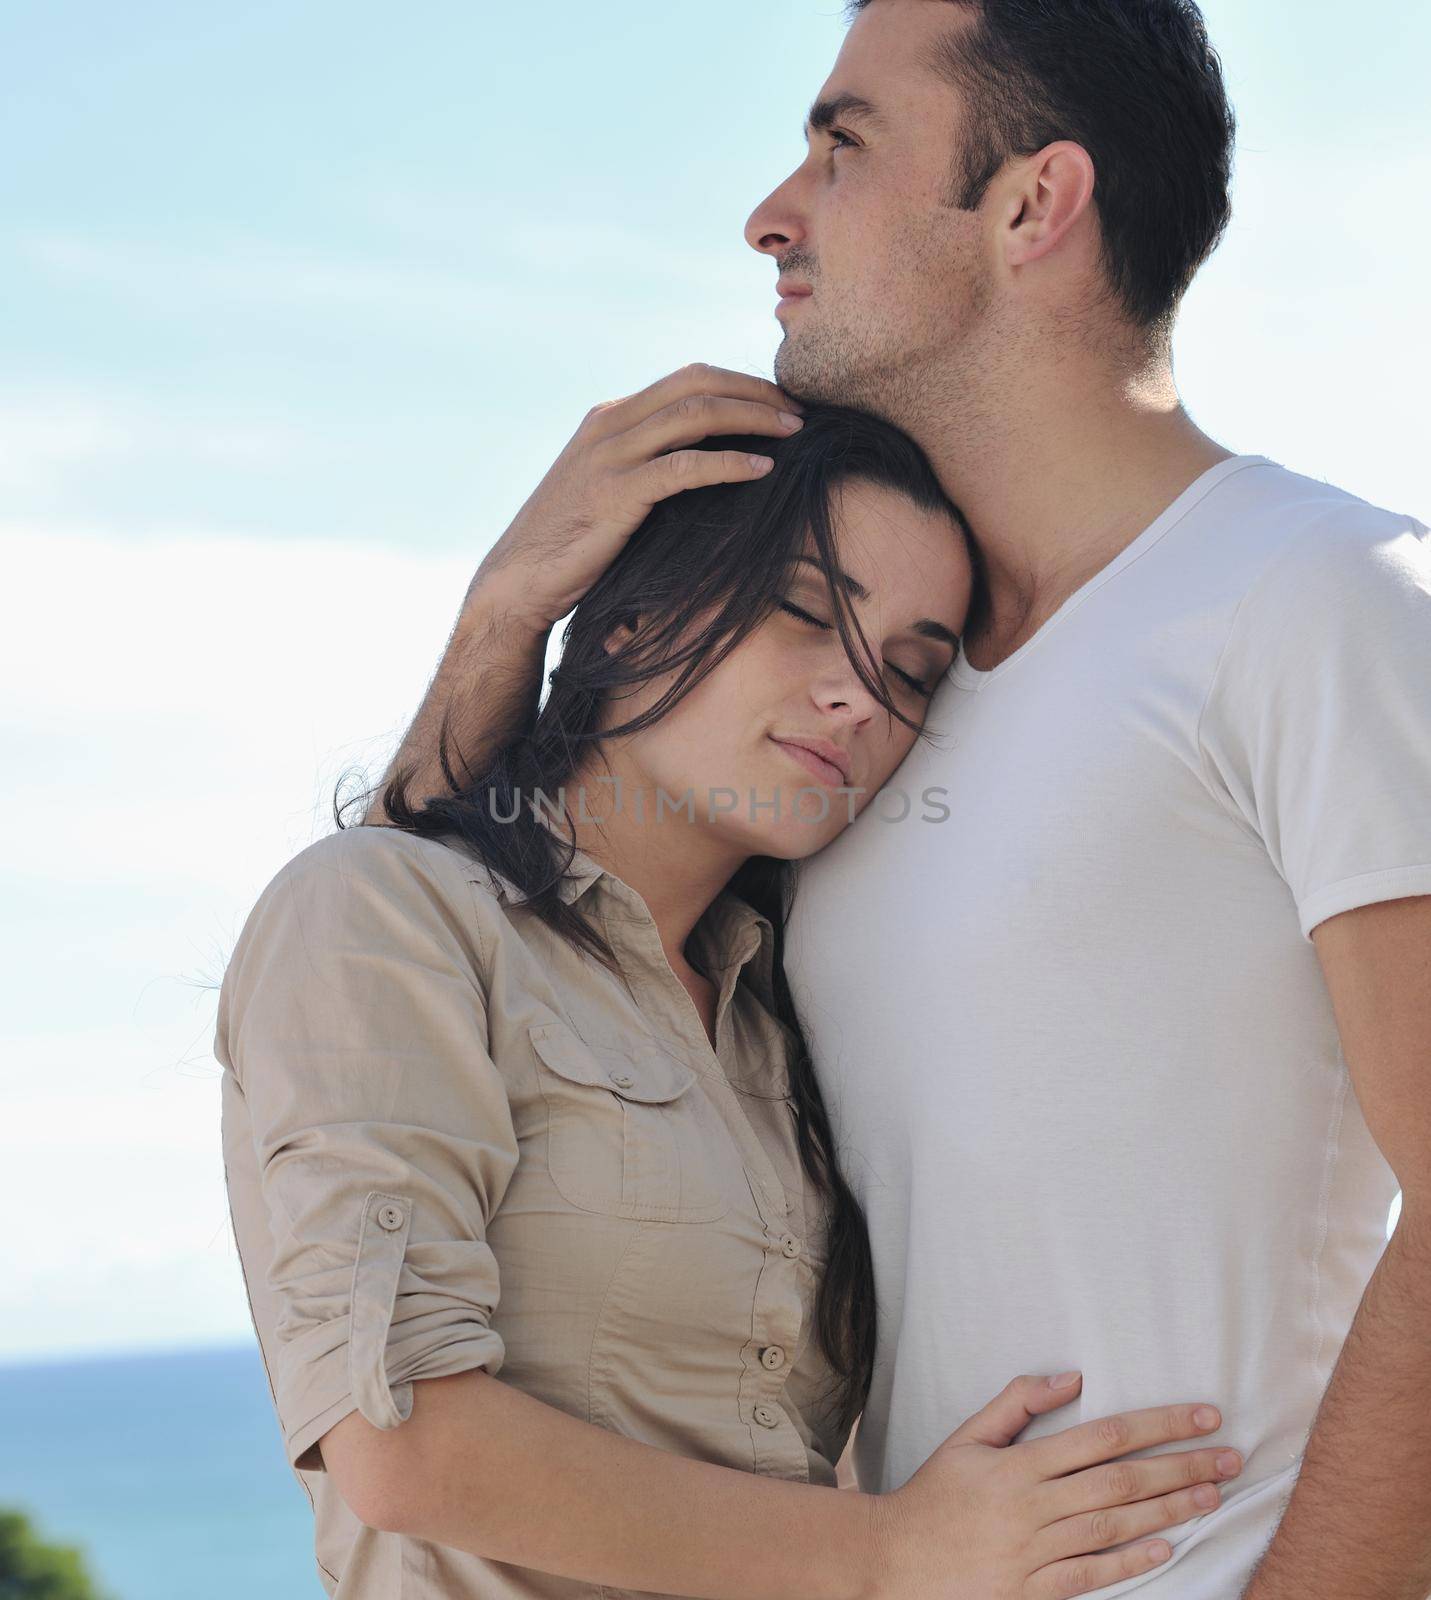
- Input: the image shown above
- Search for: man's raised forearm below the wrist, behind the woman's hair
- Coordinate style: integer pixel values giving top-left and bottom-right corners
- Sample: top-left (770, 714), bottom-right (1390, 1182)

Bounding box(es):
top-left (363, 568), bottom-right (551, 826)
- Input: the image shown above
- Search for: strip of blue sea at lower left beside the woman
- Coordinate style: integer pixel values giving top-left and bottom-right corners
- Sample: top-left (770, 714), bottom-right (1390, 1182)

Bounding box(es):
top-left (0, 1344), bottom-right (323, 1600)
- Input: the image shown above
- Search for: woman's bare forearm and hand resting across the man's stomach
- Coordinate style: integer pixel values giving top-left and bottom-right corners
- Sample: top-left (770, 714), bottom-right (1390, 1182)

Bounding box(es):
top-left (322, 1370), bottom-right (1241, 1600)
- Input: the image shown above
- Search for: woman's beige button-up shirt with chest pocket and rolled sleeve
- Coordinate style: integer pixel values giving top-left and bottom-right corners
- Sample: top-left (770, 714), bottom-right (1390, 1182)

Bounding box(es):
top-left (214, 827), bottom-right (847, 1600)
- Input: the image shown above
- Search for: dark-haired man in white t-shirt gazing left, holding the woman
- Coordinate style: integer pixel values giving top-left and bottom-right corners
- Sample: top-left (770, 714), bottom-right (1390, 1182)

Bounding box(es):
top-left (372, 0), bottom-right (1431, 1600)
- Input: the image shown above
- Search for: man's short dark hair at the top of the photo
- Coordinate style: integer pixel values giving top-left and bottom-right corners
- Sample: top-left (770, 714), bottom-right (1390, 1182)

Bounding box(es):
top-left (848, 0), bottom-right (1236, 334)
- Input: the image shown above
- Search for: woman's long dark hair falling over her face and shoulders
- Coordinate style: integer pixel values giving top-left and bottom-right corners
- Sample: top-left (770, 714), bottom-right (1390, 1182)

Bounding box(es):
top-left (335, 405), bottom-right (967, 1427)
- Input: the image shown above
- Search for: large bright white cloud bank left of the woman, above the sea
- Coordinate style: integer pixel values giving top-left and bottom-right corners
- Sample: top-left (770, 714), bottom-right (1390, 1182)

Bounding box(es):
top-left (0, 526), bottom-right (499, 1357)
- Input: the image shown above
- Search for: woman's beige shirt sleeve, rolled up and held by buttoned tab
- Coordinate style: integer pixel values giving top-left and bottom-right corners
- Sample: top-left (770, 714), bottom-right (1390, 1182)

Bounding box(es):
top-left (214, 827), bottom-right (517, 1470)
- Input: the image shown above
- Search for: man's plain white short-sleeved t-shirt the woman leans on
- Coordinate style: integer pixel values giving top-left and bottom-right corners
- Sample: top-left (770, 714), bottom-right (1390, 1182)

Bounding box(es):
top-left (786, 456), bottom-right (1431, 1600)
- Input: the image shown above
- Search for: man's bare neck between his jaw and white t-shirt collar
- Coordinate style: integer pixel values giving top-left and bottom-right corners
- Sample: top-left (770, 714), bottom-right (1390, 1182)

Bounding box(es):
top-left (916, 340), bottom-right (1233, 670)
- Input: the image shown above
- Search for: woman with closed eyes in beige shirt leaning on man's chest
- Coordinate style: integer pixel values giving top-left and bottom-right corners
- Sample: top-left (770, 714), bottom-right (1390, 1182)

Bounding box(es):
top-left (216, 380), bottom-right (1242, 1600)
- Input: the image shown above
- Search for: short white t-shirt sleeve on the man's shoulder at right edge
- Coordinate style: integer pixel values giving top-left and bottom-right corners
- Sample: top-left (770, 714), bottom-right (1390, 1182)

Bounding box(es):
top-left (1199, 504), bottom-right (1431, 939)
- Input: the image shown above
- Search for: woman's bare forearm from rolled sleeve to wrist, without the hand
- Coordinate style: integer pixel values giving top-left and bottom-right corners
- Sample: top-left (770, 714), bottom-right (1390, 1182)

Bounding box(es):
top-left (322, 1368), bottom-right (877, 1600)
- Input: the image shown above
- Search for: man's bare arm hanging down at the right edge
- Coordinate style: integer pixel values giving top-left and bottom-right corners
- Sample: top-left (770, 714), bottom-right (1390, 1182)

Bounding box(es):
top-left (1242, 894), bottom-right (1431, 1600)
